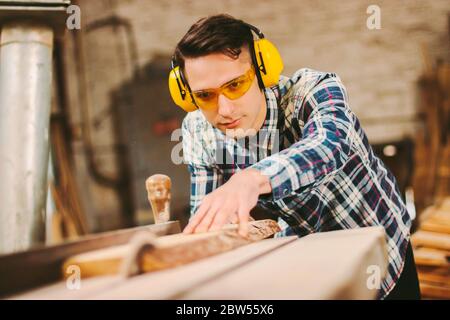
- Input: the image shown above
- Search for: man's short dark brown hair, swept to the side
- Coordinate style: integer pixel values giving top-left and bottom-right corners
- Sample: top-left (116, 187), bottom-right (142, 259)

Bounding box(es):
top-left (174, 14), bottom-right (253, 69)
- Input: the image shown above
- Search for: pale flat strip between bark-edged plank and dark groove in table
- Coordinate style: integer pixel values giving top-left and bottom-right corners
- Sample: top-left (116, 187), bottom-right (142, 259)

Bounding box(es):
top-left (9, 236), bottom-right (298, 300)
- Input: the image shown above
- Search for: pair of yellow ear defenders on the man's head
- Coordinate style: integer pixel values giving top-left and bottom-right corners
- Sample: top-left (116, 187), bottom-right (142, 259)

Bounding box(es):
top-left (169, 23), bottom-right (283, 112)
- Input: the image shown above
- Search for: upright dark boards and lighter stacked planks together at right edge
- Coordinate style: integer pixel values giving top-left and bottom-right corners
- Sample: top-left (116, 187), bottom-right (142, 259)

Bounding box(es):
top-left (412, 15), bottom-right (450, 299)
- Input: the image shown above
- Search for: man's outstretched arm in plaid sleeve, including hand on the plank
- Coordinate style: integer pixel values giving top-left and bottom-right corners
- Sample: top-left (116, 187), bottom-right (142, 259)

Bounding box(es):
top-left (184, 75), bottom-right (356, 235)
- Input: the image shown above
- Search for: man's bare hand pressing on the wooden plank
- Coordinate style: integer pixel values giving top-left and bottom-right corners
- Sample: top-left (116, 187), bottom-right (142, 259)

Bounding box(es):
top-left (183, 169), bottom-right (272, 236)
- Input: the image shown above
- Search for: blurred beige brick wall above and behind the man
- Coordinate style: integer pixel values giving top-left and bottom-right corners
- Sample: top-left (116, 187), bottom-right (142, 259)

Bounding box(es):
top-left (75, 0), bottom-right (450, 142)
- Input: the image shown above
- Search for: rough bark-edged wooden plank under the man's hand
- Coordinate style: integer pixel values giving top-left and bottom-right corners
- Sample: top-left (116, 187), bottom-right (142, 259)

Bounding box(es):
top-left (63, 220), bottom-right (281, 278)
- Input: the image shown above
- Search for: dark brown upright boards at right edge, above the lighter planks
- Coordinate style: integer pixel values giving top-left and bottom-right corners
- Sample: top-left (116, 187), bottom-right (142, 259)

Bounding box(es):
top-left (413, 46), bottom-right (450, 213)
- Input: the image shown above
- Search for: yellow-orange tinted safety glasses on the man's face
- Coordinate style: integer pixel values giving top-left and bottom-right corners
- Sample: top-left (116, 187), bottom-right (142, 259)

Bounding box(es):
top-left (192, 67), bottom-right (255, 109)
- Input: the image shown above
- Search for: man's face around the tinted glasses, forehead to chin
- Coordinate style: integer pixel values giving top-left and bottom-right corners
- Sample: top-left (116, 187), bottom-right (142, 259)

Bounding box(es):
top-left (185, 47), bottom-right (266, 137)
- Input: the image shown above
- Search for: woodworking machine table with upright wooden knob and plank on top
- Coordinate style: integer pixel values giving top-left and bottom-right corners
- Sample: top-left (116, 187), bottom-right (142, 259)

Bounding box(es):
top-left (0, 175), bottom-right (387, 299)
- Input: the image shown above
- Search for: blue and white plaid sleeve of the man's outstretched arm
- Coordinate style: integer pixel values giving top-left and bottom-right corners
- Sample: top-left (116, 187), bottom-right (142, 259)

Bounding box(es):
top-left (252, 73), bottom-right (354, 200)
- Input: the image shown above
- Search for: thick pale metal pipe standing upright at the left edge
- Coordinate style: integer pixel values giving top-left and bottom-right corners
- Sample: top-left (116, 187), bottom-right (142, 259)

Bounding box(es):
top-left (0, 20), bottom-right (54, 253)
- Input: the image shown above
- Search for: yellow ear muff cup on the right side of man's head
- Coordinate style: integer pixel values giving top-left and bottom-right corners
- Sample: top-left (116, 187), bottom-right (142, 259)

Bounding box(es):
top-left (254, 38), bottom-right (284, 87)
